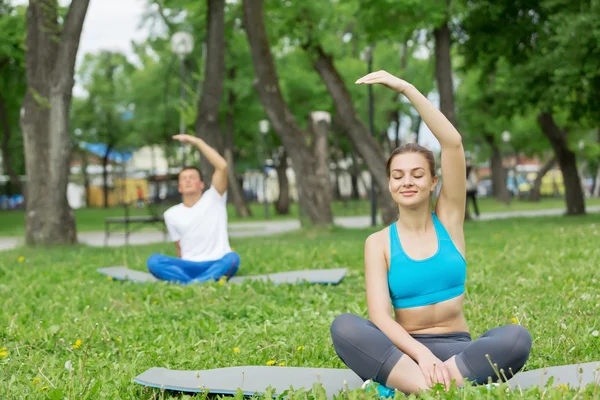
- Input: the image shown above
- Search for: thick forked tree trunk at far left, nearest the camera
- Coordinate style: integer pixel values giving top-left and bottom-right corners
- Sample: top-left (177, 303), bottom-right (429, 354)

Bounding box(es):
top-left (20, 0), bottom-right (89, 245)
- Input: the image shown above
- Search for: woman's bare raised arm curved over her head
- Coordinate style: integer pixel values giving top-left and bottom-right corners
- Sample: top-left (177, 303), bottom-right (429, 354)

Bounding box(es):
top-left (356, 71), bottom-right (467, 230)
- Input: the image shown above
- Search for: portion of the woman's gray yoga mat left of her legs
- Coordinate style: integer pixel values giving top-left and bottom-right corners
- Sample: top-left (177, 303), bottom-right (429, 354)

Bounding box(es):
top-left (134, 366), bottom-right (363, 399)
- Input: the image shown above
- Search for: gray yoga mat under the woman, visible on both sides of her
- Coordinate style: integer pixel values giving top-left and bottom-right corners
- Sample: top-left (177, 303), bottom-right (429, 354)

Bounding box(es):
top-left (134, 361), bottom-right (600, 399)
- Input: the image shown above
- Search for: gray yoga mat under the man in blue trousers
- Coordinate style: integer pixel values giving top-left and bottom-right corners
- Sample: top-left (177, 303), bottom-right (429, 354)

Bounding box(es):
top-left (97, 267), bottom-right (348, 285)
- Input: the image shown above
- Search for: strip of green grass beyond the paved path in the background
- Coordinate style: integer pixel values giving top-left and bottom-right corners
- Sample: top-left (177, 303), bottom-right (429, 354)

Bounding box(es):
top-left (0, 198), bottom-right (600, 237)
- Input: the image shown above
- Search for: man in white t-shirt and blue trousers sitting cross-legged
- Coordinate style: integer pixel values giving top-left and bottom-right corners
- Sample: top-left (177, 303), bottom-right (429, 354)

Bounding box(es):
top-left (147, 135), bottom-right (240, 284)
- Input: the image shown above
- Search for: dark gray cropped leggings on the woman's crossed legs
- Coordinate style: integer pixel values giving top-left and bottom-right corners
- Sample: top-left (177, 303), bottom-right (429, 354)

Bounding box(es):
top-left (331, 314), bottom-right (531, 385)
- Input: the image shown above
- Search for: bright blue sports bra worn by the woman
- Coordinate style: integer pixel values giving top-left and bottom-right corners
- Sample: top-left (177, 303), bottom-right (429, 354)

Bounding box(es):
top-left (388, 212), bottom-right (467, 308)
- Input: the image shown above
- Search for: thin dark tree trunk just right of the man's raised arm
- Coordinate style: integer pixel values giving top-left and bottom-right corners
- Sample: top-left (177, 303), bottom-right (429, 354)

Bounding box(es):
top-left (224, 67), bottom-right (252, 218)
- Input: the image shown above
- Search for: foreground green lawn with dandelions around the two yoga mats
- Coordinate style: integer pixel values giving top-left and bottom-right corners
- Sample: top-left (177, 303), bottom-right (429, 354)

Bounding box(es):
top-left (0, 214), bottom-right (600, 400)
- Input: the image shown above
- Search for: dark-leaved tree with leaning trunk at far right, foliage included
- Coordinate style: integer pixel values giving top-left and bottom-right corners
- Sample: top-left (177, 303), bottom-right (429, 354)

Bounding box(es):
top-left (461, 0), bottom-right (600, 215)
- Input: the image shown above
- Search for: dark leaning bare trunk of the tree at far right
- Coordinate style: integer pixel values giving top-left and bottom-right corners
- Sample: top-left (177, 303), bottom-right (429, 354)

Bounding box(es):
top-left (538, 112), bottom-right (585, 215)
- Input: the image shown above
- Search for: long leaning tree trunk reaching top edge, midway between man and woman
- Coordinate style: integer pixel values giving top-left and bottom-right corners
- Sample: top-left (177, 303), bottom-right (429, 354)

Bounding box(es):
top-left (243, 0), bottom-right (333, 225)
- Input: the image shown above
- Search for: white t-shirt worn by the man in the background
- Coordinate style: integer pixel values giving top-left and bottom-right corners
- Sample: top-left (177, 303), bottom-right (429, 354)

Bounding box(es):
top-left (164, 186), bottom-right (231, 261)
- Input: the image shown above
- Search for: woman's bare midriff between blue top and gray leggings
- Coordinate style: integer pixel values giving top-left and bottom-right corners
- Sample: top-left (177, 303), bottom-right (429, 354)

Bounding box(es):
top-left (394, 295), bottom-right (469, 334)
